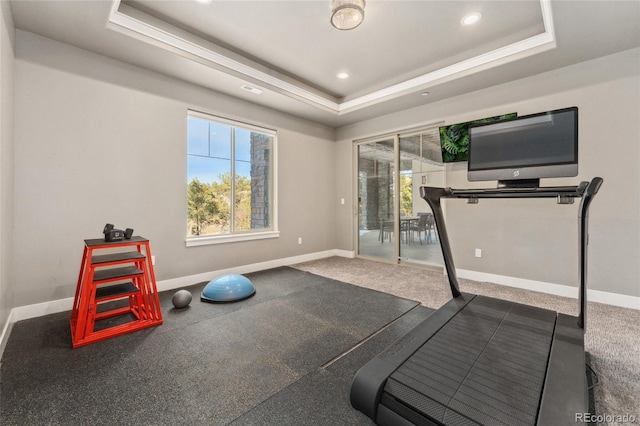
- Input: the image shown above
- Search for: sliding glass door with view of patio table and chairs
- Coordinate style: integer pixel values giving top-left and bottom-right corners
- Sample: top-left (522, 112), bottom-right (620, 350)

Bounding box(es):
top-left (356, 127), bottom-right (444, 266)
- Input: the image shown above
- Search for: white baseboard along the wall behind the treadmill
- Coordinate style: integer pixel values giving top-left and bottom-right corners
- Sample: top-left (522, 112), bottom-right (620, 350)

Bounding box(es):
top-left (456, 269), bottom-right (640, 310)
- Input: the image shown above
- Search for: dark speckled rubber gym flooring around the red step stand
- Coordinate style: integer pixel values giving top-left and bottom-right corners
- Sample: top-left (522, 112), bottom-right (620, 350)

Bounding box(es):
top-left (0, 268), bottom-right (431, 425)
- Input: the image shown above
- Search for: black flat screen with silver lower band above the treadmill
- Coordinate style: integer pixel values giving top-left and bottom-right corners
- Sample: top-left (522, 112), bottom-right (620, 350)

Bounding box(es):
top-left (467, 107), bottom-right (578, 186)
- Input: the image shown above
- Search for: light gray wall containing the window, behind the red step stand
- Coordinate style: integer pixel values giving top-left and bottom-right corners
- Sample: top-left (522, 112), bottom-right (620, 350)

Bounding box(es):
top-left (12, 31), bottom-right (335, 306)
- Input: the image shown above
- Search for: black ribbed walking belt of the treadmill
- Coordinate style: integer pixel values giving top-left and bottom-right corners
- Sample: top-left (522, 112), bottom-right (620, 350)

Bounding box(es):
top-left (381, 296), bottom-right (556, 426)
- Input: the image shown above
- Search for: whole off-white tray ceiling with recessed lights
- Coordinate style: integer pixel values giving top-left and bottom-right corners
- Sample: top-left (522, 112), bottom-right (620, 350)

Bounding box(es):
top-left (11, 0), bottom-right (640, 127)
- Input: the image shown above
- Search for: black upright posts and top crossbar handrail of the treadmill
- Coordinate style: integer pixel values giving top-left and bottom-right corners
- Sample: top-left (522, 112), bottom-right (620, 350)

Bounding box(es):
top-left (420, 177), bottom-right (603, 330)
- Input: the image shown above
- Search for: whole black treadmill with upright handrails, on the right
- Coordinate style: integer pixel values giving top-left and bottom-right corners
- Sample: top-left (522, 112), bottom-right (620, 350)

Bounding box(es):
top-left (350, 177), bottom-right (602, 426)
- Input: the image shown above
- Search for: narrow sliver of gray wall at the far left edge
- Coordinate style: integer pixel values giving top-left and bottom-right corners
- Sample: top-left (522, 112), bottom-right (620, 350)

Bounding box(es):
top-left (0, 1), bottom-right (15, 338)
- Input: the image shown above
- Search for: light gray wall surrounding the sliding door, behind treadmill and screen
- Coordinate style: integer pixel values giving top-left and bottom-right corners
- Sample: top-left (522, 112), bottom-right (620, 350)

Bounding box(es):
top-left (336, 49), bottom-right (640, 297)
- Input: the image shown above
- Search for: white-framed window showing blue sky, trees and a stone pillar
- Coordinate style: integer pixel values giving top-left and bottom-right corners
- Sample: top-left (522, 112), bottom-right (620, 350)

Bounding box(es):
top-left (187, 111), bottom-right (277, 245)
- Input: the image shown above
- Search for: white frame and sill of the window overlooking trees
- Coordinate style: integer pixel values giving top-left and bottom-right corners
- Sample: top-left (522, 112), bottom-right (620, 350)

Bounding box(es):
top-left (185, 109), bottom-right (280, 247)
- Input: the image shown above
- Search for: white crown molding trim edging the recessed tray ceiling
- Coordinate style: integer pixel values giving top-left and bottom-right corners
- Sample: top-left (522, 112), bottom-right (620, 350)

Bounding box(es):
top-left (107, 0), bottom-right (556, 115)
